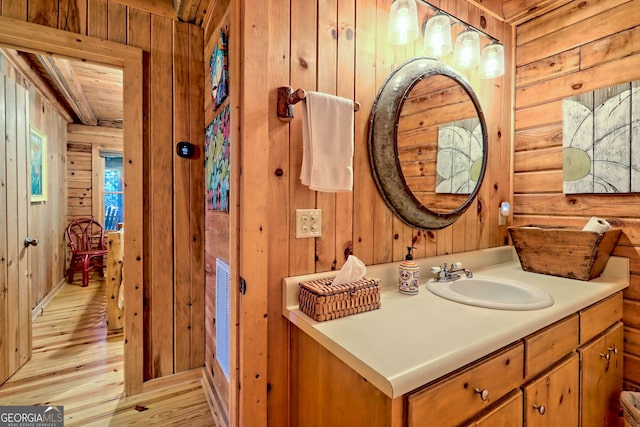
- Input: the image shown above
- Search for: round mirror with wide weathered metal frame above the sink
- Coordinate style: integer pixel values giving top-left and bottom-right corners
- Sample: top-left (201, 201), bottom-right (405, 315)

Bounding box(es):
top-left (369, 58), bottom-right (487, 230)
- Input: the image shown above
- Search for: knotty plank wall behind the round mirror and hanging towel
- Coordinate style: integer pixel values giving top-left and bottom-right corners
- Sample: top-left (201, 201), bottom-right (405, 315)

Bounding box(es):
top-left (238, 0), bottom-right (511, 426)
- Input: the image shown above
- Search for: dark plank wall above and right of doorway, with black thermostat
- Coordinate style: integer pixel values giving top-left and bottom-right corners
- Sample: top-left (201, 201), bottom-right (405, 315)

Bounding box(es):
top-left (0, 0), bottom-right (204, 380)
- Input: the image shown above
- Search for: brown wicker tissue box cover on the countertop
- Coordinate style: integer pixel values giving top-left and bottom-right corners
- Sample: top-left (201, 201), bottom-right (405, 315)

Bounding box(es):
top-left (299, 278), bottom-right (380, 321)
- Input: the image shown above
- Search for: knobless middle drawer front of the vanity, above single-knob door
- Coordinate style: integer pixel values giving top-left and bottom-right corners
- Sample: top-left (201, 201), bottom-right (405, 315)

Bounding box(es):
top-left (524, 314), bottom-right (578, 378)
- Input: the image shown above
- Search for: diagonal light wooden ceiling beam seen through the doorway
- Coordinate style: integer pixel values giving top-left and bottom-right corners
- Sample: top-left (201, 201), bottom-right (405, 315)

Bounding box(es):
top-left (37, 55), bottom-right (98, 126)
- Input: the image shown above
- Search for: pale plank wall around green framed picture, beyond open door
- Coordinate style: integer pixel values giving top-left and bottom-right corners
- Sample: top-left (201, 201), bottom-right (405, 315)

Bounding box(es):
top-left (4, 55), bottom-right (67, 309)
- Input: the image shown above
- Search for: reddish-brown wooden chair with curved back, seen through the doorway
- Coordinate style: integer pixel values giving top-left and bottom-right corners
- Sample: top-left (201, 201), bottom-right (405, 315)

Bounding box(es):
top-left (67, 218), bottom-right (107, 287)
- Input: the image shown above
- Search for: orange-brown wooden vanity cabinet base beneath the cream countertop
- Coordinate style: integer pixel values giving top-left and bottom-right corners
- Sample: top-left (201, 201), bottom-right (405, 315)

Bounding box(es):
top-left (290, 292), bottom-right (623, 427)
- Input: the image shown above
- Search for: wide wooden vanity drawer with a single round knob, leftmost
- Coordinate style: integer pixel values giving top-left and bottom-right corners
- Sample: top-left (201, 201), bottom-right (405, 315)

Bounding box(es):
top-left (407, 342), bottom-right (524, 427)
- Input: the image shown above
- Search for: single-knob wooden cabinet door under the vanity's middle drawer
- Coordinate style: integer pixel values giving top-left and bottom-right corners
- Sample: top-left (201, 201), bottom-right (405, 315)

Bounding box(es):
top-left (524, 353), bottom-right (579, 427)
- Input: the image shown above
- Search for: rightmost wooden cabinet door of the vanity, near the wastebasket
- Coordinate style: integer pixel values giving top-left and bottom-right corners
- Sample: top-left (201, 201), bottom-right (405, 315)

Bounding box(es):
top-left (580, 323), bottom-right (624, 427)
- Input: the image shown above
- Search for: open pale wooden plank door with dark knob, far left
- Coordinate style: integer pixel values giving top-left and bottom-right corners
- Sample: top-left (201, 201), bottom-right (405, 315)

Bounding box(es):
top-left (0, 74), bottom-right (31, 384)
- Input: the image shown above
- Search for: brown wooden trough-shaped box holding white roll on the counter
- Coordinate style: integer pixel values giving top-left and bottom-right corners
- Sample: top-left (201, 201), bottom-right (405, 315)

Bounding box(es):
top-left (509, 225), bottom-right (621, 280)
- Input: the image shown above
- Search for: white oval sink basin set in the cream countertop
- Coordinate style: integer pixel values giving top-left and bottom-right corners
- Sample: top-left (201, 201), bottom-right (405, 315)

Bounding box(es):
top-left (427, 277), bottom-right (553, 310)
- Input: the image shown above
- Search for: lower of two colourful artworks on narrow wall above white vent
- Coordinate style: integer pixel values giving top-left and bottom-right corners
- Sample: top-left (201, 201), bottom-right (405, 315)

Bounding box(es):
top-left (204, 105), bottom-right (231, 212)
